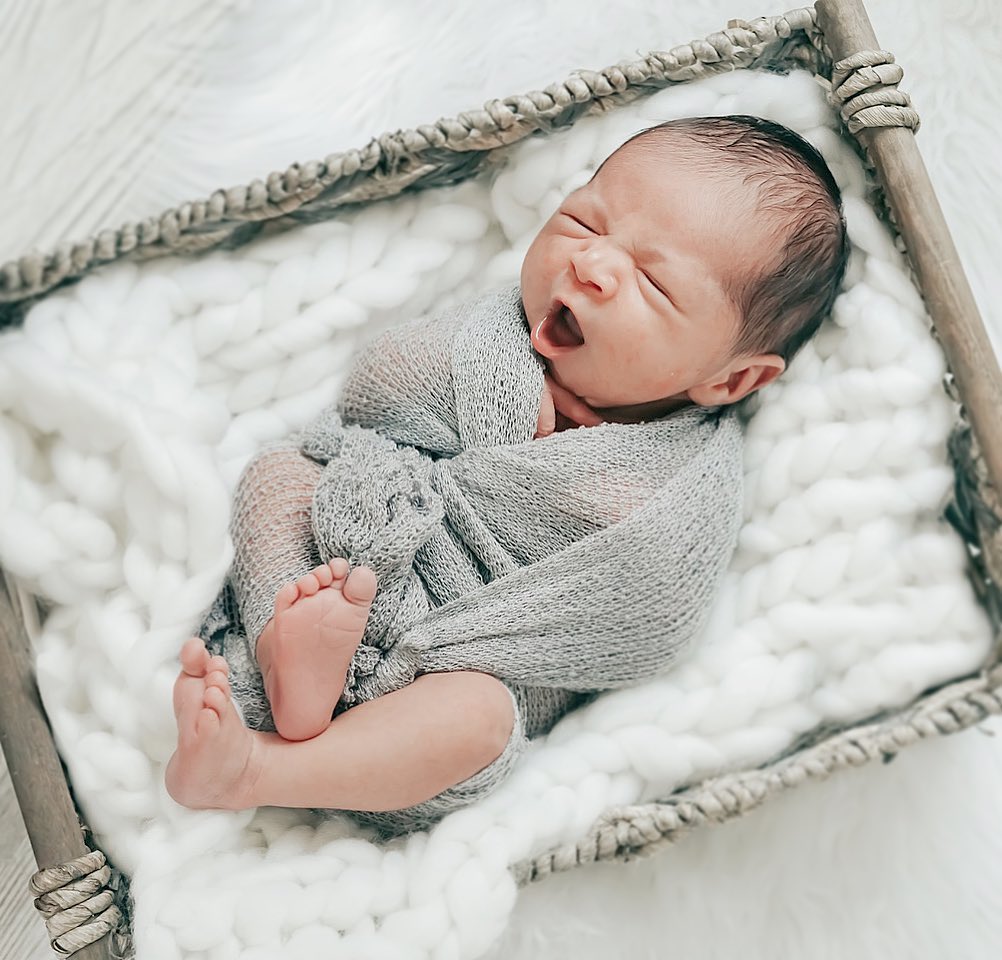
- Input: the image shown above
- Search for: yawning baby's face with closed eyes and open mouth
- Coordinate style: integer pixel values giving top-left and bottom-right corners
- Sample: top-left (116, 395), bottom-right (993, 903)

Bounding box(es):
top-left (521, 145), bottom-right (770, 416)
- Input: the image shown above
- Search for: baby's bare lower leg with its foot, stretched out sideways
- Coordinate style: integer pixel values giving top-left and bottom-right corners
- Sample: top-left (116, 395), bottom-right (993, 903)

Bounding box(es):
top-left (166, 638), bottom-right (514, 811)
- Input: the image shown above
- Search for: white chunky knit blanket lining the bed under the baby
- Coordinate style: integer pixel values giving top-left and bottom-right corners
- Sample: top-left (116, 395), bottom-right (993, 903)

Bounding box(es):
top-left (0, 63), bottom-right (989, 960)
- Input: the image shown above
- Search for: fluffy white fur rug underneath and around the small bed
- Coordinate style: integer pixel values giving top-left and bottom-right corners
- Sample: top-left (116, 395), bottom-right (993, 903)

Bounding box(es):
top-left (0, 2), bottom-right (1002, 957)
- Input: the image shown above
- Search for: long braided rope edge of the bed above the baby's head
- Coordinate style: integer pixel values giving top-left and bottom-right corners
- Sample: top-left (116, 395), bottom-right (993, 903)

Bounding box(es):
top-left (0, 7), bottom-right (822, 325)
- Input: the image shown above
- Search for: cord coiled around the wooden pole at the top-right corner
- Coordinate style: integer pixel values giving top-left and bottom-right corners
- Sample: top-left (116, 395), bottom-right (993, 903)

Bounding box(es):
top-left (831, 50), bottom-right (920, 133)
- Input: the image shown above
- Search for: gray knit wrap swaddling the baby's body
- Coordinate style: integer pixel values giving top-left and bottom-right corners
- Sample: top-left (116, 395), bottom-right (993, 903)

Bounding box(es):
top-left (205, 288), bottom-right (742, 753)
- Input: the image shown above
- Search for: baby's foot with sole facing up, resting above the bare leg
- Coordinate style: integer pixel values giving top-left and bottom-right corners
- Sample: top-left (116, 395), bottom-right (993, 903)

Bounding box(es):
top-left (258, 558), bottom-right (376, 740)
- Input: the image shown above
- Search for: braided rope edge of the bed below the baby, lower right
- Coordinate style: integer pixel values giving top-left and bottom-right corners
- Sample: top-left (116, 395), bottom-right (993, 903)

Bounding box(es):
top-left (512, 665), bottom-right (1002, 885)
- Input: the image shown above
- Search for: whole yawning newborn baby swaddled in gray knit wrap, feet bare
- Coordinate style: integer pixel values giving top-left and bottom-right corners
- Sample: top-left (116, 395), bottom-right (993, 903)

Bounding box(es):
top-left (166, 117), bottom-right (848, 830)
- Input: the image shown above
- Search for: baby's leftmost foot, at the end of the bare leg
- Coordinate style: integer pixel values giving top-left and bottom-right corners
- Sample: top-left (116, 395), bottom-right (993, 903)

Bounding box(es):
top-left (164, 636), bottom-right (254, 810)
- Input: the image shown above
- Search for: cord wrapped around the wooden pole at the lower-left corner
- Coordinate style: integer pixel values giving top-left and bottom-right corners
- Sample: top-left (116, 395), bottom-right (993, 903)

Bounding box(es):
top-left (28, 850), bottom-right (121, 957)
